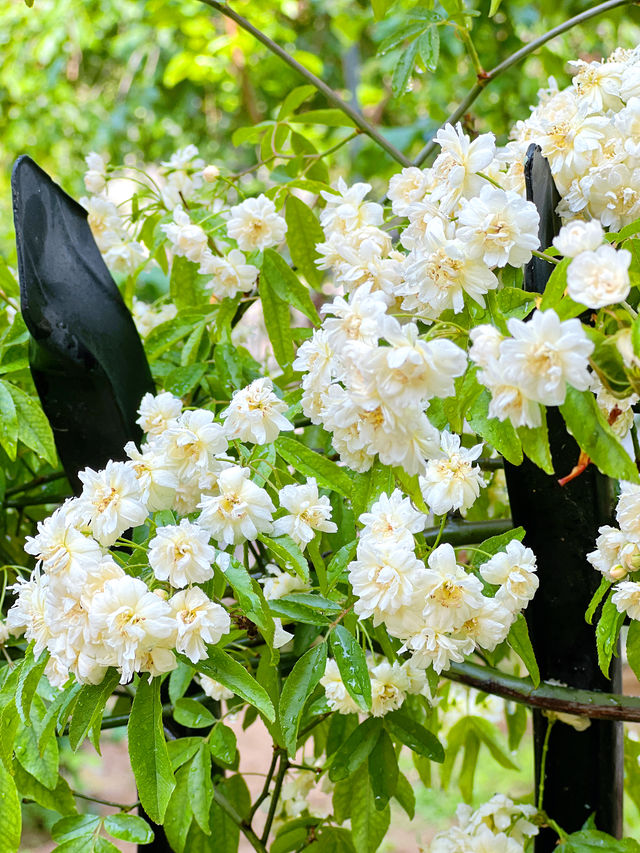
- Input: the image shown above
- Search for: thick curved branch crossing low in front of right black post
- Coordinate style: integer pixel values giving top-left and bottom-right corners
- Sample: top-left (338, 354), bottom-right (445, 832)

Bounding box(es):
top-left (442, 663), bottom-right (640, 723)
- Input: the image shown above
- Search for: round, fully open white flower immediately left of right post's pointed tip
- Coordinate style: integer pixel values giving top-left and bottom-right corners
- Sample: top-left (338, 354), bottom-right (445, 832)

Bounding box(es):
top-left (457, 186), bottom-right (540, 267)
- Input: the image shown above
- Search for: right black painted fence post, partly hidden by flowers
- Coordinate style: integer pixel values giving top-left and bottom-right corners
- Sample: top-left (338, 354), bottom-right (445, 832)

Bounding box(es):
top-left (505, 145), bottom-right (623, 853)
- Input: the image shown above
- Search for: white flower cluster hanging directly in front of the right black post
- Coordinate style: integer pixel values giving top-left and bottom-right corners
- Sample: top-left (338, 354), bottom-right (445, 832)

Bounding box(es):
top-left (469, 309), bottom-right (594, 427)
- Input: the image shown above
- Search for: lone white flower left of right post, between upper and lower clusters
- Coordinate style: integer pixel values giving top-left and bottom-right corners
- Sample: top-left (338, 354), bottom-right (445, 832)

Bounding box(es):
top-left (420, 432), bottom-right (486, 515)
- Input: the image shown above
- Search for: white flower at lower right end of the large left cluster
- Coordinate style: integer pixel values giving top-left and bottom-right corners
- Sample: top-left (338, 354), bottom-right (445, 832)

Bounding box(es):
top-left (168, 586), bottom-right (231, 663)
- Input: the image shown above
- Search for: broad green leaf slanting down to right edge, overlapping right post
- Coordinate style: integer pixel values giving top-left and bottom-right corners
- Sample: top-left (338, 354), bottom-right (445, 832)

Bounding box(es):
top-left (560, 385), bottom-right (640, 483)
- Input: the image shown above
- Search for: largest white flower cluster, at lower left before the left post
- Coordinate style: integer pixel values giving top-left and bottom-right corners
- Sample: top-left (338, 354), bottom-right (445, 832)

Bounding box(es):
top-left (7, 379), bottom-right (336, 686)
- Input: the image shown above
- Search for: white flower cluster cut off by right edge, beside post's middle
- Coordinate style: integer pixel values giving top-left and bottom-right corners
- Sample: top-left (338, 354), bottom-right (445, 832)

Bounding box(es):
top-left (587, 482), bottom-right (640, 619)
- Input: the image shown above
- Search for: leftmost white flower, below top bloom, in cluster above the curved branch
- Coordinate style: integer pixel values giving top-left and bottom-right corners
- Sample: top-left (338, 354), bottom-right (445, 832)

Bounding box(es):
top-left (347, 539), bottom-right (425, 624)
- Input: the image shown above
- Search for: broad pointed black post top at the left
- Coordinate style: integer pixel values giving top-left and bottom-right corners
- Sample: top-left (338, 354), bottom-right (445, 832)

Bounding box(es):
top-left (11, 156), bottom-right (154, 490)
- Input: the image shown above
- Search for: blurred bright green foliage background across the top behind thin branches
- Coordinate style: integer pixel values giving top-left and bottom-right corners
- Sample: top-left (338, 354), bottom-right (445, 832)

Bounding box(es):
top-left (0, 0), bottom-right (640, 255)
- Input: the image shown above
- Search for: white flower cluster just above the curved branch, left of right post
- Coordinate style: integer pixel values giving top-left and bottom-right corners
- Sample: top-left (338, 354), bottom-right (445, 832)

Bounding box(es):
top-left (324, 490), bottom-right (538, 680)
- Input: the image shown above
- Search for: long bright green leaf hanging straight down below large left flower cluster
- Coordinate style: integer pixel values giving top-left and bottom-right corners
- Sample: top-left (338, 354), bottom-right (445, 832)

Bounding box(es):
top-left (127, 678), bottom-right (176, 823)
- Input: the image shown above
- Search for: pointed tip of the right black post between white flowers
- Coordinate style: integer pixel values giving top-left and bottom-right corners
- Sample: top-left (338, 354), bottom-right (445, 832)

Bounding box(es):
top-left (524, 143), bottom-right (562, 293)
